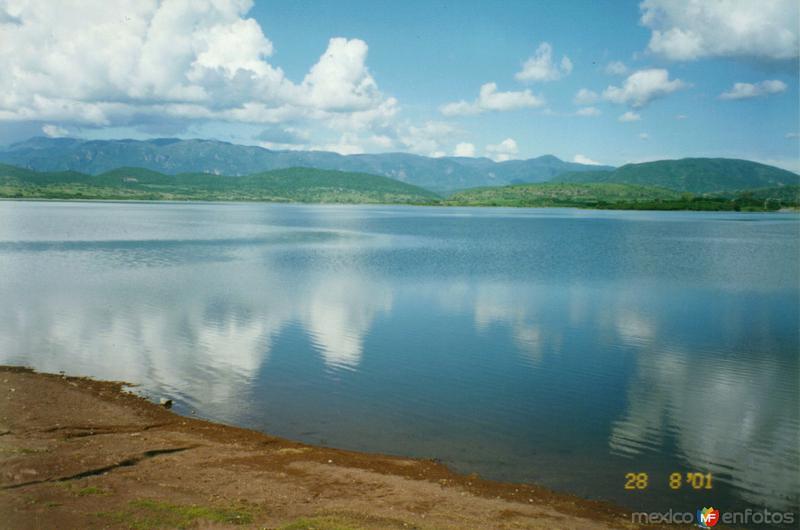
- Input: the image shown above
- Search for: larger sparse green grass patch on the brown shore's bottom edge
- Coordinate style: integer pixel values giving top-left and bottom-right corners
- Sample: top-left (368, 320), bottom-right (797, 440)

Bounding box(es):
top-left (97, 499), bottom-right (253, 530)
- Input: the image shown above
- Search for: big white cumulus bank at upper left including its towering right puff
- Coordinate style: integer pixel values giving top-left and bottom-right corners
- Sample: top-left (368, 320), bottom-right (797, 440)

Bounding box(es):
top-left (0, 0), bottom-right (398, 142)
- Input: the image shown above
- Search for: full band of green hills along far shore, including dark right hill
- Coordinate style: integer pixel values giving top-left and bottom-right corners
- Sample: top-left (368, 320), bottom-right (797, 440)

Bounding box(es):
top-left (0, 159), bottom-right (800, 211)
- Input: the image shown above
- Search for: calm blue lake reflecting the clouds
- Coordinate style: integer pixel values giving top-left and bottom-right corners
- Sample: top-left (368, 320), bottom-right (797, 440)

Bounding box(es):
top-left (0, 201), bottom-right (800, 513)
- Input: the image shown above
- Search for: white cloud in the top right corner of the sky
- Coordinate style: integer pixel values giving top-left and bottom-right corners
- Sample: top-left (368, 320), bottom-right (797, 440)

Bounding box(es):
top-left (640, 0), bottom-right (800, 61)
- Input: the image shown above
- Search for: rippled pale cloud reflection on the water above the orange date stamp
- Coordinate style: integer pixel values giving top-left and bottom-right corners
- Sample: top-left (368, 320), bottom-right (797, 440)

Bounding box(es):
top-left (609, 338), bottom-right (800, 510)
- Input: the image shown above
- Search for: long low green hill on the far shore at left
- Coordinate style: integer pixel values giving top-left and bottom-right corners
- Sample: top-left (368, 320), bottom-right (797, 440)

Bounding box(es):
top-left (0, 165), bottom-right (439, 204)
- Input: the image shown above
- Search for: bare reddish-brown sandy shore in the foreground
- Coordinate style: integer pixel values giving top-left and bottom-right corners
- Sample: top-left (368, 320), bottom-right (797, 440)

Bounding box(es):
top-left (0, 367), bottom-right (648, 529)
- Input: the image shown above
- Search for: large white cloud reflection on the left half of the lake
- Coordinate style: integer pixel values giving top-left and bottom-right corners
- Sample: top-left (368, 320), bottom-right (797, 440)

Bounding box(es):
top-left (0, 245), bottom-right (392, 412)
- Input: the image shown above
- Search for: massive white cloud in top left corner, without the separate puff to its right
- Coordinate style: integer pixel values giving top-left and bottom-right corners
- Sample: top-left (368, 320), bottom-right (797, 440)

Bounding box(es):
top-left (0, 1), bottom-right (276, 124)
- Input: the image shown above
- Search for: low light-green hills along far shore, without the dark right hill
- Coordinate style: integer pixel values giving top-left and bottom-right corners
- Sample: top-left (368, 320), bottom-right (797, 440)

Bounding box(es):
top-left (0, 164), bottom-right (800, 211)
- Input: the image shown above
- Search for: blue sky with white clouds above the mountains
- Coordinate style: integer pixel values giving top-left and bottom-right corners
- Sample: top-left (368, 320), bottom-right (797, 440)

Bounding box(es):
top-left (0, 0), bottom-right (800, 171)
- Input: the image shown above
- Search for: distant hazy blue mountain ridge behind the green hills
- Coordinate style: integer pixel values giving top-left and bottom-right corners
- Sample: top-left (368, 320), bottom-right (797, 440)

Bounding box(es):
top-left (0, 137), bottom-right (613, 192)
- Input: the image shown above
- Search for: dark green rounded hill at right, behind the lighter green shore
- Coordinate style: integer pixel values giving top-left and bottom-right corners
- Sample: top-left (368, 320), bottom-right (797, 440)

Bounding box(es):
top-left (551, 158), bottom-right (800, 193)
